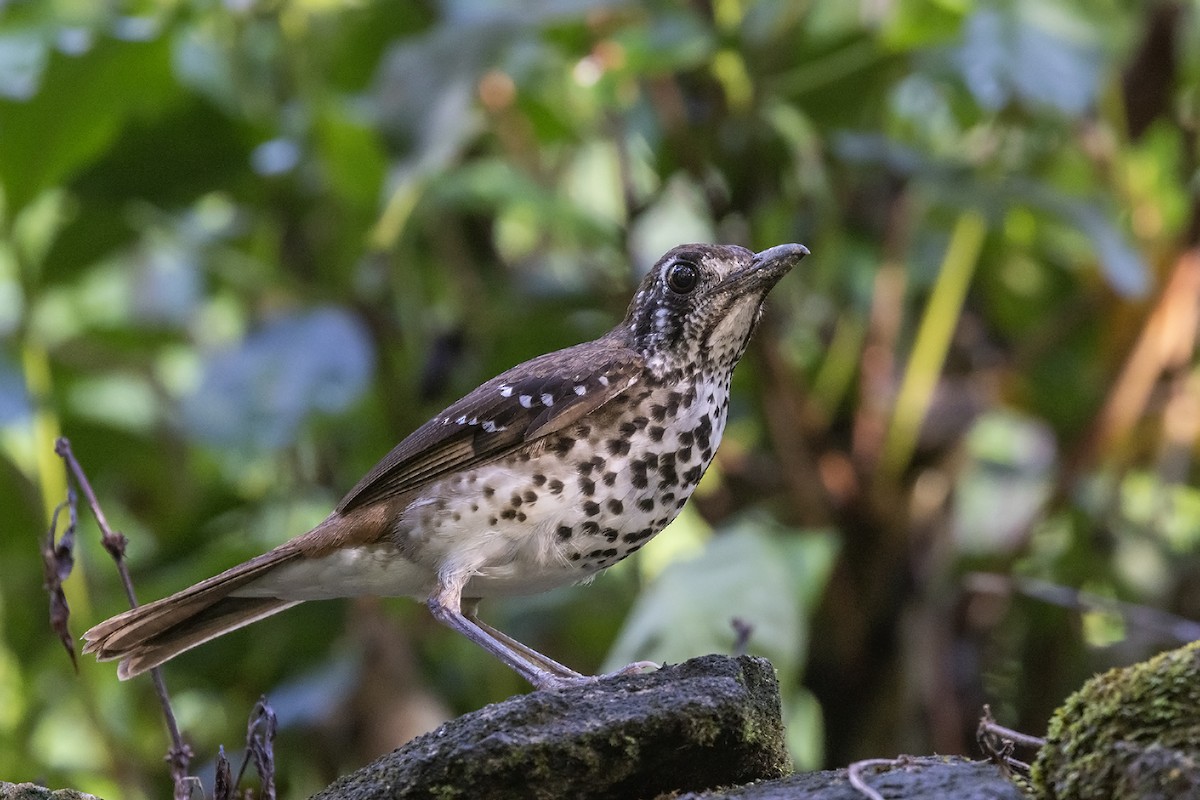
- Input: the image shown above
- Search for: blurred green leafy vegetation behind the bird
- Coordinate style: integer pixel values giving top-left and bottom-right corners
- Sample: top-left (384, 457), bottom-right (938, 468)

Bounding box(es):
top-left (0, 0), bottom-right (1200, 798)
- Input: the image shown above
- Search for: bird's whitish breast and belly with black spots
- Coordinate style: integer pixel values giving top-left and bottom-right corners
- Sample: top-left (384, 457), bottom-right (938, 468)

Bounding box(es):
top-left (396, 374), bottom-right (728, 597)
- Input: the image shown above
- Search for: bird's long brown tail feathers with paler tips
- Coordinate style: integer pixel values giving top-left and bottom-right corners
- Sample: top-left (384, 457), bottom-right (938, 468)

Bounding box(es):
top-left (83, 546), bottom-right (301, 680)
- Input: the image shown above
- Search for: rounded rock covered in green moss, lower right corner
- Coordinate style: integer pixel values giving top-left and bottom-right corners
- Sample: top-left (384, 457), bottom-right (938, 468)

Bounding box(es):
top-left (1032, 642), bottom-right (1200, 800)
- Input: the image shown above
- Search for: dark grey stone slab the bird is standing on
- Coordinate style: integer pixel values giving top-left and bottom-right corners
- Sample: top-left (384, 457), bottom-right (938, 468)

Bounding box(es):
top-left (314, 656), bottom-right (791, 800)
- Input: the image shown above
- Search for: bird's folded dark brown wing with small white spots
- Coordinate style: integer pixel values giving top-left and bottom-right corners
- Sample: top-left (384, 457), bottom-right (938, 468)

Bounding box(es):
top-left (337, 339), bottom-right (643, 515)
